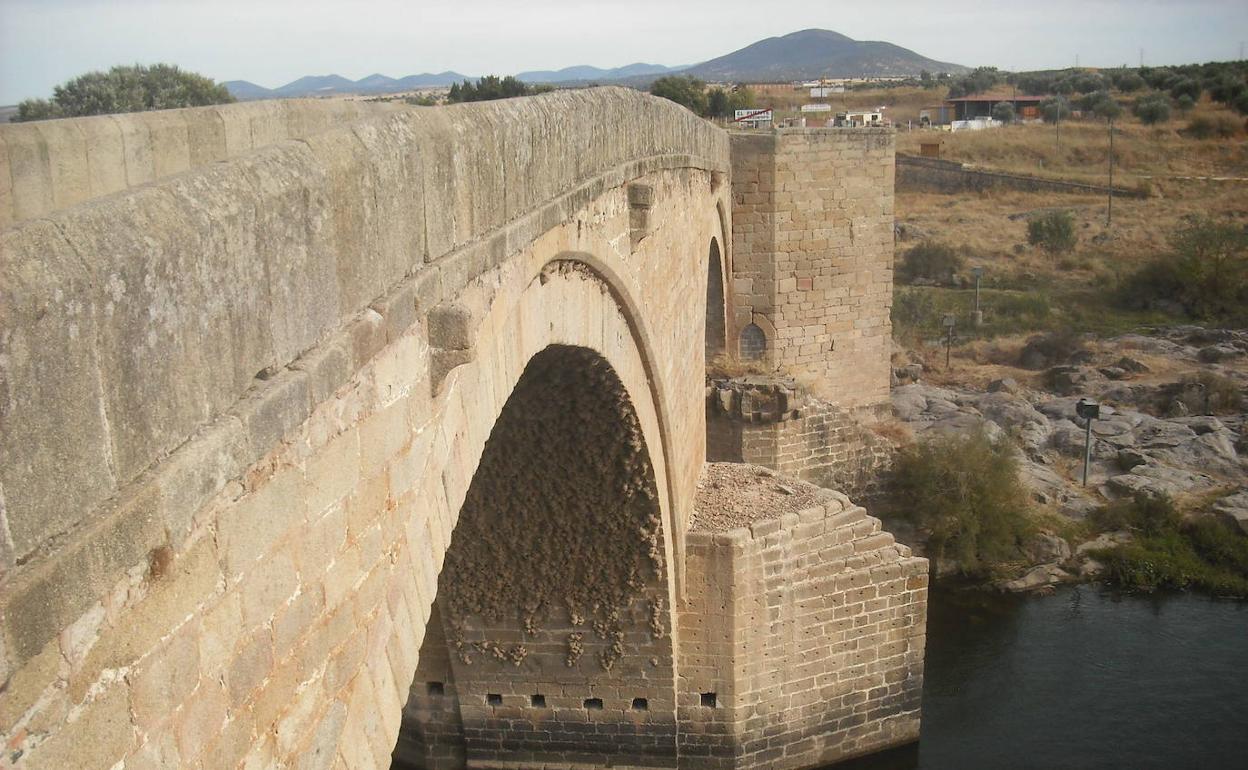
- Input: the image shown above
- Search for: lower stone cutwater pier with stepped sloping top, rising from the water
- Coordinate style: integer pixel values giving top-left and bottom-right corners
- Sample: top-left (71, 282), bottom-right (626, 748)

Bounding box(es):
top-left (679, 494), bottom-right (927, 769)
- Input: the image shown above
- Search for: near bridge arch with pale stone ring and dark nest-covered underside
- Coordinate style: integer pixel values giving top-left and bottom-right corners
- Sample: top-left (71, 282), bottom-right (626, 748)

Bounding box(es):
top-left (396, 253), bottom-right (679, 768)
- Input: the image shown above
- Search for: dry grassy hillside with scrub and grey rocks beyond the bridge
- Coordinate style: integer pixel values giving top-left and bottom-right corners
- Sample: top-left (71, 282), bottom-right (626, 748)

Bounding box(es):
top-left (860, 64), bottom-right (1248, 597)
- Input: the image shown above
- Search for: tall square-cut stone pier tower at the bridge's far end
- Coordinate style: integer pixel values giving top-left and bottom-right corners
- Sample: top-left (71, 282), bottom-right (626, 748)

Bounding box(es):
top-left (733, 129), bottom-right (894, 409)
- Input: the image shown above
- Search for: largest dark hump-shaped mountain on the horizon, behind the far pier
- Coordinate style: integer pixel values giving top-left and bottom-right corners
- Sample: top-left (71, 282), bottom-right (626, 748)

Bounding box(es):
top-left (684, 30), bottom-right (970, 82)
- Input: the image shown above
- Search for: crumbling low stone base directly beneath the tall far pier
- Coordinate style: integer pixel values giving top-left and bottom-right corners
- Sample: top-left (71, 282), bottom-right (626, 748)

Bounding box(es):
top-left (706, 376), bottom-right (892, 497)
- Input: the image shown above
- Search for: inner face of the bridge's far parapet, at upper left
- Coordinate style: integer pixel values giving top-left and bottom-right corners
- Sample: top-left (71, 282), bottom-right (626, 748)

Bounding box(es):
top-left (0, 99), bottom-right (404, 227)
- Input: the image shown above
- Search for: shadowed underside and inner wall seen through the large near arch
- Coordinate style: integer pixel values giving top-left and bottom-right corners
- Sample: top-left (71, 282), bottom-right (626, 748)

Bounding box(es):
top-left (396, 344), bottom-right (676, 769)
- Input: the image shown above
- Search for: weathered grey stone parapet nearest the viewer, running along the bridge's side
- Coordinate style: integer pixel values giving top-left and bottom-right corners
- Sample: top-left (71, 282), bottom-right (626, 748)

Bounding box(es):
top-left (0, 89), bottom-right (728, 568)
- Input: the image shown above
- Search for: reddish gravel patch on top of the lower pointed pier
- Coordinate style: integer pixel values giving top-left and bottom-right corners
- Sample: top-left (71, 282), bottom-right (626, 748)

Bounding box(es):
top-left (693, 463), bottom-right (827, 532)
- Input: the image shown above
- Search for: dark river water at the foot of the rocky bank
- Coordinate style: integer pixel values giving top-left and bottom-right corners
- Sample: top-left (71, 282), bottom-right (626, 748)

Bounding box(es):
top-left (836, 585), bottom-right (1248, 770)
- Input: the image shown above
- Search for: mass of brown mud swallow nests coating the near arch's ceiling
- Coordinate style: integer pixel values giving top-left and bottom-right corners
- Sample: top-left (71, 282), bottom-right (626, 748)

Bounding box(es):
top-left (438, 346), bottom-right (664, 670)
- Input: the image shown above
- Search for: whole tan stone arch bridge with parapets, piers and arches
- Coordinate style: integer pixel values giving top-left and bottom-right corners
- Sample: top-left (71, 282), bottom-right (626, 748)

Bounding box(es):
top-left (0, 89), bottom-right (926, 769)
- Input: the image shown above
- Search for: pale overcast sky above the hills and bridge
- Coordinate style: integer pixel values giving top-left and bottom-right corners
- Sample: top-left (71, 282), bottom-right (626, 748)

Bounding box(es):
top-left (0, 0), bottom-right (1248, 105)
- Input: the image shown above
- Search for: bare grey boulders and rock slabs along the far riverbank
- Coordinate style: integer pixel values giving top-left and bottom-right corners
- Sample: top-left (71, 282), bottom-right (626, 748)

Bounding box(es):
top-left (892, 327), bottom-right (1248, 590)
